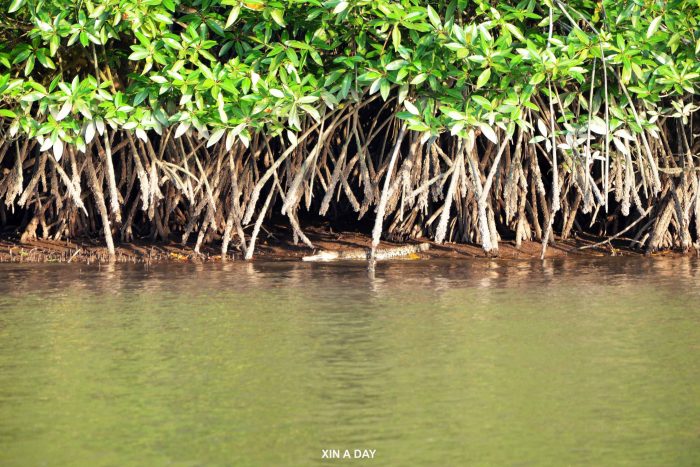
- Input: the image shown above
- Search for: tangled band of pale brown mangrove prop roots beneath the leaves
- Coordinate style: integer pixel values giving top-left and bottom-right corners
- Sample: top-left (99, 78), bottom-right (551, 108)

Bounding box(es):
top-left (0, 99), bottom-right (700, 259)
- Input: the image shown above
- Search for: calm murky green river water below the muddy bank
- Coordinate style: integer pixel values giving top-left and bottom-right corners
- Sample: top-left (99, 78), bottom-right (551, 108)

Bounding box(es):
top-left (0, 258), bottom-right (700, 466)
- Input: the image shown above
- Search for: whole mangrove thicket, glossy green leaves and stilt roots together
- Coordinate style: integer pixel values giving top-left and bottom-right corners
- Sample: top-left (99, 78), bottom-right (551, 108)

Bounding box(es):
top-left (0, 0), bottom-right (700, 260)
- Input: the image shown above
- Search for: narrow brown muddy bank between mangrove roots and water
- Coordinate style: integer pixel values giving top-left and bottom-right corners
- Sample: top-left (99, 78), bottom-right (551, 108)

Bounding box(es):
top-left (0, 227), bottom-right (698, 264)
